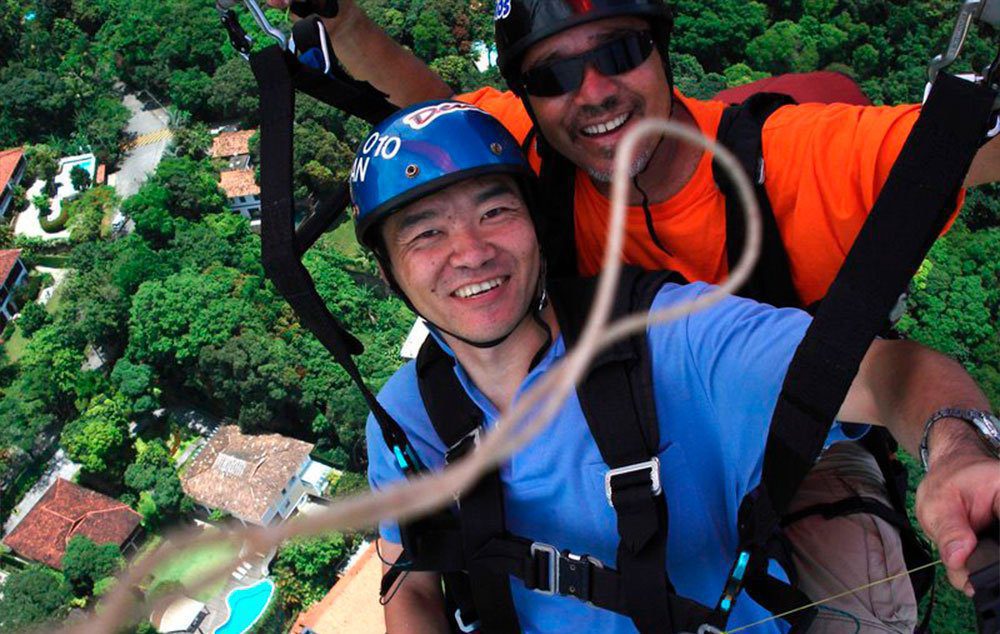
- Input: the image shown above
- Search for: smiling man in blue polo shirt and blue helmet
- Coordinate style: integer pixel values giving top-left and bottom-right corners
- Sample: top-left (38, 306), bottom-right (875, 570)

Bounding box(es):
top-left (351, 102), bottom-right (1000, 632)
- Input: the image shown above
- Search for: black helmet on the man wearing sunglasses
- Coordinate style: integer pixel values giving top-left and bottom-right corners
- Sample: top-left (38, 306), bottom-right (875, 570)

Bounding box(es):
top-left (493, 0), bottom-right (673, 92)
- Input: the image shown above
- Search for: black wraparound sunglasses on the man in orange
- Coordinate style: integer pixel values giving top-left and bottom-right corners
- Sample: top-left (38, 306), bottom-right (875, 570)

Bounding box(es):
top-left (521, 31), bottom-right (655, 97)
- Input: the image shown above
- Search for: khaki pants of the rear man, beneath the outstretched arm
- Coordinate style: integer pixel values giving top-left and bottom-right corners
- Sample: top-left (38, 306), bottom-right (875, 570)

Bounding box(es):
top-left (785, 442), bottom-right (917, 634)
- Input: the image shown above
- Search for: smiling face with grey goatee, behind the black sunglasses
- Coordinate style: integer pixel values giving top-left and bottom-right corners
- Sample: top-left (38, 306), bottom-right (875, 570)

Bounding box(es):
top-left (521, 17), bottom-right (672, 182)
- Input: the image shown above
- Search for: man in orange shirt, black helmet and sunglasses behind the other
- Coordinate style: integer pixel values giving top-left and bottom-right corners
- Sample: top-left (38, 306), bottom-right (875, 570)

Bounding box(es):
top-left (269, 0), bottom-right (1000, 632)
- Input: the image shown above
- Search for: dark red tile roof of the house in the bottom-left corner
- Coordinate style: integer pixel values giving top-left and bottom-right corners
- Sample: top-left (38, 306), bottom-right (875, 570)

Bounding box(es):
top-left (3, 478), bottom-right (142, 569)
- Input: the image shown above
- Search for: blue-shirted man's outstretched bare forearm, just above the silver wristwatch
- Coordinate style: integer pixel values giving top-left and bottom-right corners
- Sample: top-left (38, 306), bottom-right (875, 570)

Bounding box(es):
top-left (840, 341), bottom-right (989, 456)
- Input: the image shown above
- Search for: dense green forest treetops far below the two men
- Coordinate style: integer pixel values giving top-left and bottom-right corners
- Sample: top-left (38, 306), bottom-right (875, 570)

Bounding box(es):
top-left (0, 0), bottom-right (1000, 631)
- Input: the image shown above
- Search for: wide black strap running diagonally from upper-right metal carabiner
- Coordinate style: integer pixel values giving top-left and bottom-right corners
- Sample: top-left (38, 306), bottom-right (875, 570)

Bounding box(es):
top-left (740, 69), bottom-right (996, 624)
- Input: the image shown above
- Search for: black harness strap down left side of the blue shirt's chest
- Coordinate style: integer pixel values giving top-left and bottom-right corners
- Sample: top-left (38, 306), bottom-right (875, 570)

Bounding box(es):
top-left (417, 338), bottom-right (520, 632)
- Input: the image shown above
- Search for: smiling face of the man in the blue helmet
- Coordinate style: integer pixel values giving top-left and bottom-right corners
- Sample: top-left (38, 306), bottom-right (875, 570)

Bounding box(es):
top-left (381, 175), bottom-right (541, 343)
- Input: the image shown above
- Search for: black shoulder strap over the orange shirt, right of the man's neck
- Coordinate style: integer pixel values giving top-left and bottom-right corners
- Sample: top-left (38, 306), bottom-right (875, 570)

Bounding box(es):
top-left (712, 93), bottom-right (801, 306)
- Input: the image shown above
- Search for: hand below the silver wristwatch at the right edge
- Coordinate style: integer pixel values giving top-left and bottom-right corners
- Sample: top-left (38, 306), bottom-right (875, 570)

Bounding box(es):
top-left (917, 440), bottom-right (1000, 597)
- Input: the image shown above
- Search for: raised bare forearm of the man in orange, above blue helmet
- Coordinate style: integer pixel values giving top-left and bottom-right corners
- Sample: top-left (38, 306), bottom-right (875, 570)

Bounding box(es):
top-left (324, 0), bottom-right (452, 107)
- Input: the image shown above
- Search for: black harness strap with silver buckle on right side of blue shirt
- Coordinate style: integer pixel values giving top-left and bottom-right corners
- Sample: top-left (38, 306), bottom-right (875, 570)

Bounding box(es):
top-left (551, 267), bottom-right (685, 632)
